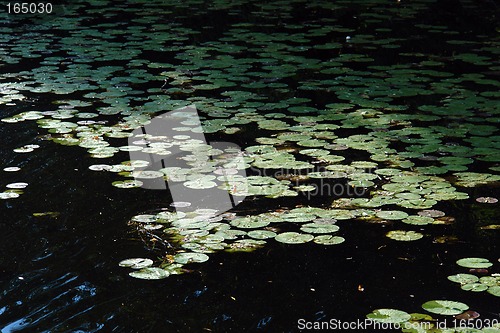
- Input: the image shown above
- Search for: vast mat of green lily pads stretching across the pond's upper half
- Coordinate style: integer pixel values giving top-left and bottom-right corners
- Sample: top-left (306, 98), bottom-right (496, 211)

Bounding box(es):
top-left (0, 0), bottom-right (500, 288)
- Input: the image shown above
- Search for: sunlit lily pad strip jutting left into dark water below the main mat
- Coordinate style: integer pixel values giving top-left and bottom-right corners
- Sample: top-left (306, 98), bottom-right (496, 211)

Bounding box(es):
top-left (120, 203), bottom-right (346, 279)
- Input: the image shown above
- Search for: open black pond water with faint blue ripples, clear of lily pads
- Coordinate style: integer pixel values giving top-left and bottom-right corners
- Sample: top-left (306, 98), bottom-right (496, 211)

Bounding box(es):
top-left (0, 1), bottom-right (500, 333)
